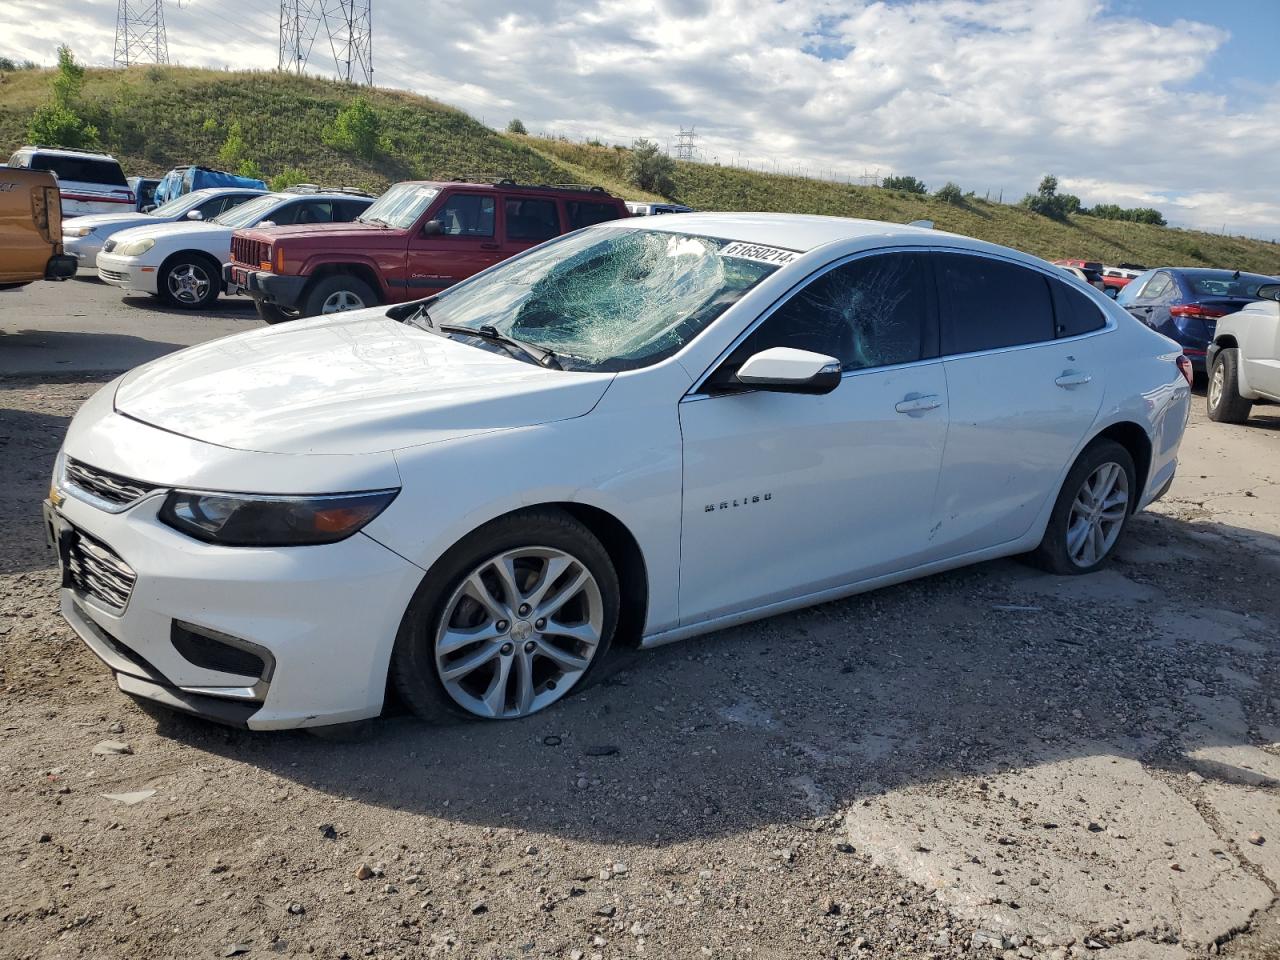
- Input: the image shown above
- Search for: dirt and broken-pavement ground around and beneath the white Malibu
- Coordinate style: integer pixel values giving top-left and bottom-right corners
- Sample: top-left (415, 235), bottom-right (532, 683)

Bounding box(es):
top-left (0, 288), bottom-right (1280, 960)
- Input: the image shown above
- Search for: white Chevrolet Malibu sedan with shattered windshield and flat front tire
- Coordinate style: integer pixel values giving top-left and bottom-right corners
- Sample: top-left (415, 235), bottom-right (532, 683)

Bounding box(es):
top-left (46, 214), bottom-right (1189, 730)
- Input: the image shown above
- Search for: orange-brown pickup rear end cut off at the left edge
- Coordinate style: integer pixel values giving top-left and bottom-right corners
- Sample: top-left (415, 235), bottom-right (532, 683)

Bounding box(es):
top-left (0, 166), bottom-right (76, 291)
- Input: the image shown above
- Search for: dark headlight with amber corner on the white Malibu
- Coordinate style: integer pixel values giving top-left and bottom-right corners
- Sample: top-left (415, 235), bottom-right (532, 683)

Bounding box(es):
top-left (160, 490), bottom-right (399, 547)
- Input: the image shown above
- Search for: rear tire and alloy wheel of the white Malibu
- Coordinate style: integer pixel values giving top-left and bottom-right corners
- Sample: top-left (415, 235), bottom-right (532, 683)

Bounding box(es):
top-left (1027, 439), bottom-right (1139, 575)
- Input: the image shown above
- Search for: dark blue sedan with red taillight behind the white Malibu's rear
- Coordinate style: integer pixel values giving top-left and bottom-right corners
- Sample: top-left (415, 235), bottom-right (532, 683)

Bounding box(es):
top-left (1116, 266), bottom-right (1276, 374)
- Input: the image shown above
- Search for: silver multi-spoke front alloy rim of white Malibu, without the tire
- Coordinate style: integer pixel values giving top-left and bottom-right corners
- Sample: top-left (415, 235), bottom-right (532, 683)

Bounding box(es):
top-left (435, 547), bottom-right (604, 719)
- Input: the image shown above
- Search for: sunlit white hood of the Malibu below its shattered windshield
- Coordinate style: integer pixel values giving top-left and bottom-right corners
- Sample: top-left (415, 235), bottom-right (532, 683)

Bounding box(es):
top-left (115, 308), bottom-right (613, 453)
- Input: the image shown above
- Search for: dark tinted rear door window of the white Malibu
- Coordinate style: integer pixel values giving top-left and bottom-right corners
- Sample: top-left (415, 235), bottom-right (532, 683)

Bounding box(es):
top-left (934, 253), bottom-right (1053, 355)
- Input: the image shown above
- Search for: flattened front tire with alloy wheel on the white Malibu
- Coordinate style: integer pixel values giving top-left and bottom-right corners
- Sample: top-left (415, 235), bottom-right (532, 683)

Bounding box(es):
top-left (390, 509), bottom-right (621, 721)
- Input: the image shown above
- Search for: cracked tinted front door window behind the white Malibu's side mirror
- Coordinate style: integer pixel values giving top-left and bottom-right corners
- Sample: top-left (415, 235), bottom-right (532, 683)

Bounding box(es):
top-left (735, 253), bottom-right (928, 370)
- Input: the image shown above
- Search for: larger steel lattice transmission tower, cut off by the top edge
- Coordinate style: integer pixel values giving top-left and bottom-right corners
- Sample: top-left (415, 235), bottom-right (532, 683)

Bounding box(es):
top-left (279, 0), bottom-right (374, 84)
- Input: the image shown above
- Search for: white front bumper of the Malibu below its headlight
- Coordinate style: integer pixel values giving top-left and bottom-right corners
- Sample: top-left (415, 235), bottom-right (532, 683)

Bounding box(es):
top-left (46, 484), bottom-right (422, 730)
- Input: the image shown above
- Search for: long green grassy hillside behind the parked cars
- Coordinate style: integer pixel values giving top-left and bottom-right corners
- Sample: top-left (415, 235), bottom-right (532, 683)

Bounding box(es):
top-left (0, 67), bottom-right (1280, 274)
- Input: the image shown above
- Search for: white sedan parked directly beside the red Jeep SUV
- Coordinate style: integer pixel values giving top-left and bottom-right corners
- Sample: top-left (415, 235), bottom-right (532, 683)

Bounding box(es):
top-left (97, 191), bottom-right (374, 310)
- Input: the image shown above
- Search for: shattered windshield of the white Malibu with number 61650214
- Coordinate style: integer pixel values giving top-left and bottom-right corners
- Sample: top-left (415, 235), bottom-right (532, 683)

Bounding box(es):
top-left (430, 227), bottom-right (778, 371)
